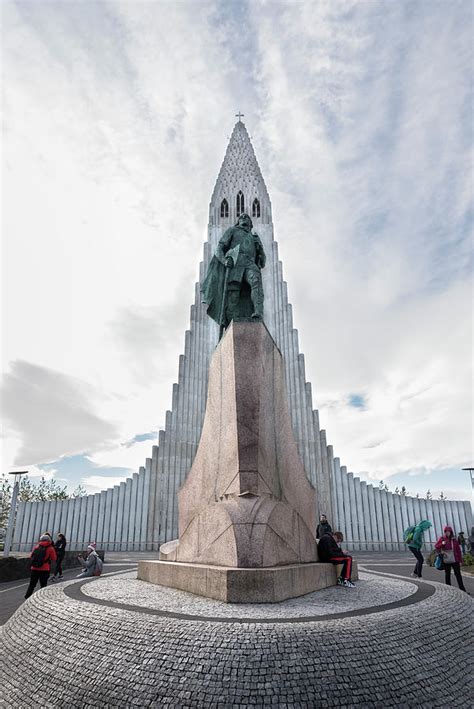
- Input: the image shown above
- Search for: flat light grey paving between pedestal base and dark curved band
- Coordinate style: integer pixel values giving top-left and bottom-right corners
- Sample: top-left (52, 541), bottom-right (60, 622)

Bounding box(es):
top-left (82, 572), bottom-right (417, 618)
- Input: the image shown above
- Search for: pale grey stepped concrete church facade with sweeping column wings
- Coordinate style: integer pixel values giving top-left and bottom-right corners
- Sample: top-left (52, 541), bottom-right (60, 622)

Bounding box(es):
top-left (12, 119), bottom-right (472, 551)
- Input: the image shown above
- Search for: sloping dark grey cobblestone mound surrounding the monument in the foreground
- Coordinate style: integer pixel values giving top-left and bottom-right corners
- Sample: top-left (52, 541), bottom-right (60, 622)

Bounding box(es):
top-left (0, 584), bottom-right (473, 709)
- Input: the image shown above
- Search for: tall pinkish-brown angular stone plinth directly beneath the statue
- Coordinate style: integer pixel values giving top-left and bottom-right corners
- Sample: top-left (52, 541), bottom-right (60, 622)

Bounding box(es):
top-left (175, 322), bottom-right (317, 568)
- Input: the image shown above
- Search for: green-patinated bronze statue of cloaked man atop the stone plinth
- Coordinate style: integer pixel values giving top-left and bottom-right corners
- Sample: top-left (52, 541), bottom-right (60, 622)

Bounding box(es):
top-left (201, 214), bottom-right (265, 338)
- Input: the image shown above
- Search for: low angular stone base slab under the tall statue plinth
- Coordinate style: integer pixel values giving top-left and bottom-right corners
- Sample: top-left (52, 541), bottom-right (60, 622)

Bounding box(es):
top-left (138, 561), bottom-right (358, 603)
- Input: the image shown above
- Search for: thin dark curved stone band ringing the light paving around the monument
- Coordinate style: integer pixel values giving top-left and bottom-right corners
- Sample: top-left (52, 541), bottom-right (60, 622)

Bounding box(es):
top-left (63, 572), bottom-right (436, 625)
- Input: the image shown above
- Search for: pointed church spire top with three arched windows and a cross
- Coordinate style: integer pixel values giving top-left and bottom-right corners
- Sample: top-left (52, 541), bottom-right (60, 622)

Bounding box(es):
top-left (209, 121), bottom-right (272, 227)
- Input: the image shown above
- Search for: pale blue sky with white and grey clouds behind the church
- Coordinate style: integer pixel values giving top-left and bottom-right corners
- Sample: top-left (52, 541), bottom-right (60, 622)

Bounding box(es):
top-left (1, 0), bottom-right (474, 499)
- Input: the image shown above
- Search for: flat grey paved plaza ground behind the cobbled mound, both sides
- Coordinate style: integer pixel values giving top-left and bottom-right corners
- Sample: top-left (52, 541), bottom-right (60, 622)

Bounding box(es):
top-left (0, 552), bottom-right (474, 625)
